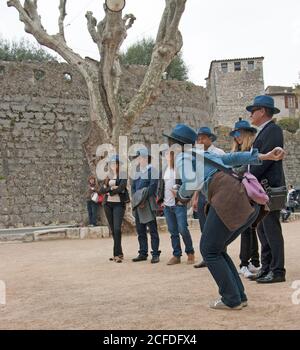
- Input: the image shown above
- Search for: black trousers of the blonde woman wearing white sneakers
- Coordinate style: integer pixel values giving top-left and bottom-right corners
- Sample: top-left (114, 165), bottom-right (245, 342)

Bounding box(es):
top-left (240, 227), bottom-right (260, 267)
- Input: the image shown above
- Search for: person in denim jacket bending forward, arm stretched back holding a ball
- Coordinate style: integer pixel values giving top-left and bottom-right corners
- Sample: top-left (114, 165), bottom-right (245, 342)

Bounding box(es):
top-left (165, 124), bottom-right (285, 310)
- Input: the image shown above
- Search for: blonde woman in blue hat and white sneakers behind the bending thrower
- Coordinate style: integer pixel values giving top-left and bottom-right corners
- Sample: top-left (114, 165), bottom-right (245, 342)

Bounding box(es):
top-left (229, 118), bottom-right (260, 278)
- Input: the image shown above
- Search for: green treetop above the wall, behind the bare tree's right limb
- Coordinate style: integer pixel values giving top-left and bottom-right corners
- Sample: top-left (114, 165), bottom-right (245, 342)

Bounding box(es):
top-left (120, 38), bottom-right (188, 80)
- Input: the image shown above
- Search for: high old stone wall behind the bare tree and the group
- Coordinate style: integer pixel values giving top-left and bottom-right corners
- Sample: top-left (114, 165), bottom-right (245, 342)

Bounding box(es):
top-left (0, 62), bottom-right (209, 228)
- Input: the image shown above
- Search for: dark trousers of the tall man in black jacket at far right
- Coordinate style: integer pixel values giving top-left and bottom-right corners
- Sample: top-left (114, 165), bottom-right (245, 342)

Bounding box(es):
top-left (257, 210), bottom-right (285, 275)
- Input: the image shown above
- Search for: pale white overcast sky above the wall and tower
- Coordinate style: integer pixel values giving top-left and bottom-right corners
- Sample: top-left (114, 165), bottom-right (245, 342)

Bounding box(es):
top-left (0, 0), bottom-right (300, 87)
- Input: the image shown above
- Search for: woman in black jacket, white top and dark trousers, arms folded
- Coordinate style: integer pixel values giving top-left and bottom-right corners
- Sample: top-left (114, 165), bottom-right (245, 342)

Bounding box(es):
top-left (100, 155), bottom-right (129, 263)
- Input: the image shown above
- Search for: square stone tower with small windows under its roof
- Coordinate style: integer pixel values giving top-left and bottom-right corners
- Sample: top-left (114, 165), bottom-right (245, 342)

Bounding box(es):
top-left (206, 57), bottom-right (264, 126)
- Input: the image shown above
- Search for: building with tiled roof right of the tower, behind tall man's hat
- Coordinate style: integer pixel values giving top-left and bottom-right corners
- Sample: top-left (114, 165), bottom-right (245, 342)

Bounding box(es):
top-left (266, 86), bottom-right (300, 118)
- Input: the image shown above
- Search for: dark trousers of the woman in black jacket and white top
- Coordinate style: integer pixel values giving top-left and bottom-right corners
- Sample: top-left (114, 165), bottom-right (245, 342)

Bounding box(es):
top-left (104, 202), bottom-right (125, 256)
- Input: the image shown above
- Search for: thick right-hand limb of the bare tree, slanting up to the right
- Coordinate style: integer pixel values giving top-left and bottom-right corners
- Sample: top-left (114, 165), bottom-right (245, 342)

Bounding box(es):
top-left (124, 0), bottom-right (186, 126)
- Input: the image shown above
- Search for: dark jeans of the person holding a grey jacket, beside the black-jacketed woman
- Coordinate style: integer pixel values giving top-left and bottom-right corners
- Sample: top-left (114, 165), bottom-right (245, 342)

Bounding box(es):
top-left (135, 214), bottom-right (160, 256)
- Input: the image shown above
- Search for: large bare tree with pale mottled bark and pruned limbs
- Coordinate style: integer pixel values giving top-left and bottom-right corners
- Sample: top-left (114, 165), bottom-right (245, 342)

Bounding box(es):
top-left (7, 0), bottom-right (186, 171)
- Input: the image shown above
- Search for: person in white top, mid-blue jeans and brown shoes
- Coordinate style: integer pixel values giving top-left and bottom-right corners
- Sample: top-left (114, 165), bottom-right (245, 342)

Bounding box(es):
top-left (157, 150), bottom-right (195, 265)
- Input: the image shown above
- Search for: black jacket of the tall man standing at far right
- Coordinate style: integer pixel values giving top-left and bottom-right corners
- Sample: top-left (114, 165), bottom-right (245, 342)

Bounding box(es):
top-left (250, 121), bottom-right (285, 187)
